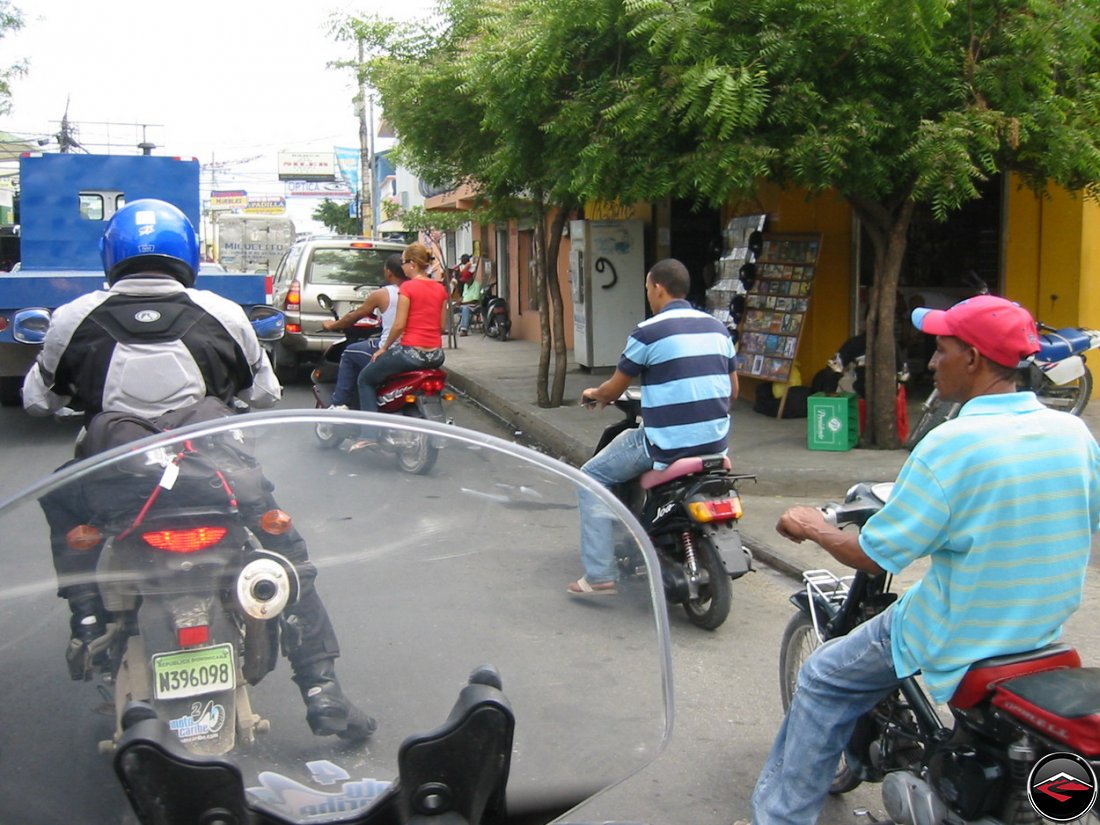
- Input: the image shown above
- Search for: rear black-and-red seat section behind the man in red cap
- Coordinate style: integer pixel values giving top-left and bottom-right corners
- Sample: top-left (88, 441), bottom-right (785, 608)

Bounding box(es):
top-left (993, 668), bottom-right (1100, 758)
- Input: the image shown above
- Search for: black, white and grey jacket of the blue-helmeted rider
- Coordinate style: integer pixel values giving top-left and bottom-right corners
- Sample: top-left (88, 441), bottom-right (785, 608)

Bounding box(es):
top-left (23, 274), bottom-right (282, 420)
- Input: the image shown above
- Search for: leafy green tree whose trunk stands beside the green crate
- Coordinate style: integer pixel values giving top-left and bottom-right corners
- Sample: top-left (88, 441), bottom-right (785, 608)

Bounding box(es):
top-left (594, 0), bottom-right (1100, 448)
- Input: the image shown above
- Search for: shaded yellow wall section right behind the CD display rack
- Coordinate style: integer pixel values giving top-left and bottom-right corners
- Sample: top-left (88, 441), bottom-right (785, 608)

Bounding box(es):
top-left (725, 184), bottom-right (853, 399)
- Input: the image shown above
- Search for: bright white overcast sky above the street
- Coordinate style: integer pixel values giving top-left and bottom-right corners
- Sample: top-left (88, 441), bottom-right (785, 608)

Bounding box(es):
top-left (0, 0), bottom-right (433, 230)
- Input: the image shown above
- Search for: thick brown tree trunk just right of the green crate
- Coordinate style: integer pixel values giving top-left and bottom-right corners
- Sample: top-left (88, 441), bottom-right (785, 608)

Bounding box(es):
top-left (851, 197), bottom-right (915, 450)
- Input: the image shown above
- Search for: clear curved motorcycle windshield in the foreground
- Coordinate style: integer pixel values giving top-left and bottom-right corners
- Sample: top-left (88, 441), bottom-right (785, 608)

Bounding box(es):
top-left (0, 410), bottom-right (671, 823)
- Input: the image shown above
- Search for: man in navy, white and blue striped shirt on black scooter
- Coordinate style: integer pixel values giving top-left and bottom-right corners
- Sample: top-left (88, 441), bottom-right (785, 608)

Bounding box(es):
top-left (568, 259), bottom-right (737, 596)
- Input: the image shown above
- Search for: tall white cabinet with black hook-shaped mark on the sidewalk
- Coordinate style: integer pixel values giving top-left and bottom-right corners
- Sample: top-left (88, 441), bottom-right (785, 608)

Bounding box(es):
top-left (569, 220), bottom-right (646, 369)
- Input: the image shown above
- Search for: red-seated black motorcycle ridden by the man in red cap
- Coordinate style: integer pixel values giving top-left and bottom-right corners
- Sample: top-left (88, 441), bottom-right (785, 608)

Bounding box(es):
top-left (779, 483), bottom-right (1100, 825)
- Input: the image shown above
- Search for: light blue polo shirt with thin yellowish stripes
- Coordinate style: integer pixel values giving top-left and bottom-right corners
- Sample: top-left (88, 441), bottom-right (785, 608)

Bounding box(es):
top-left (859, 393), bottom-right (1100, 702)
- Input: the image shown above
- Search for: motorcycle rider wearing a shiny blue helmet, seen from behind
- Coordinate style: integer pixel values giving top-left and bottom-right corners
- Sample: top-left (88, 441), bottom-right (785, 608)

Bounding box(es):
top-left (23, 199), bottom-right (375, 739)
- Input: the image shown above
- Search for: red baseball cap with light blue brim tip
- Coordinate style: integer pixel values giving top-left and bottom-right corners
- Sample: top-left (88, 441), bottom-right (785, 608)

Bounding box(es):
top-left (913, 295), bottom-right (1038, 366)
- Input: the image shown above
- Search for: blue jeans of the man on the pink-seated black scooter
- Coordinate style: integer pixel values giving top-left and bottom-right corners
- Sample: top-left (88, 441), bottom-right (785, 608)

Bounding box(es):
top-left (576, 427), bottom-right (653, 583)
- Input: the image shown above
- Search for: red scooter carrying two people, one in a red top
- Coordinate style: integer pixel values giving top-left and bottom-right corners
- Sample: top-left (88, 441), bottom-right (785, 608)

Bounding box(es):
top-left (309, 295), bottom-right (454, 474)
